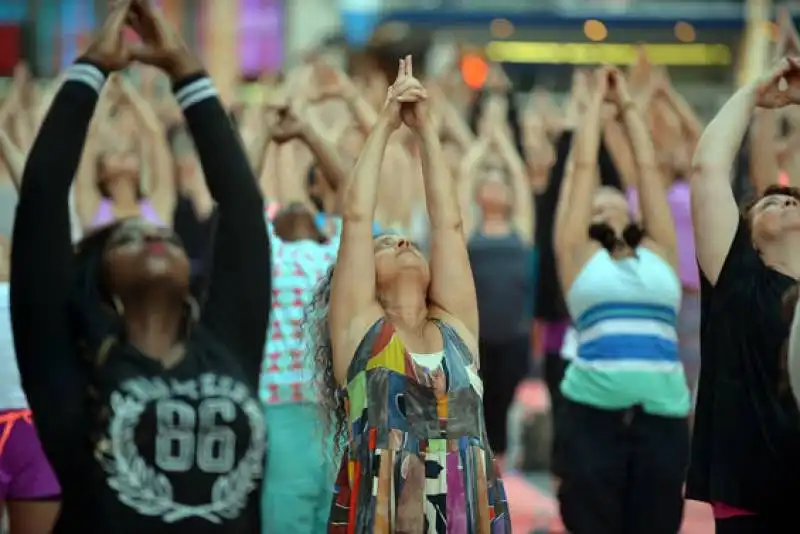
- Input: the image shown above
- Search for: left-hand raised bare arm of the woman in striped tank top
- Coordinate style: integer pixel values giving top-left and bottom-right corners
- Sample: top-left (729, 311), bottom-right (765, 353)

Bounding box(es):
top-left (553, 73), bottom-right (605, 294)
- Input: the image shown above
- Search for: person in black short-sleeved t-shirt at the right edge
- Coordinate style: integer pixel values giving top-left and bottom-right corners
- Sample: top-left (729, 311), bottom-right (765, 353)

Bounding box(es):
top-left (687, 60), bottom-right (800, 534)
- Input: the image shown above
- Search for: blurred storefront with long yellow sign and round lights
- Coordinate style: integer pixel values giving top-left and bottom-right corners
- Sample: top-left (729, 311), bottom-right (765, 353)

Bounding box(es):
top-left (382, 0), bottom-right (764, 113)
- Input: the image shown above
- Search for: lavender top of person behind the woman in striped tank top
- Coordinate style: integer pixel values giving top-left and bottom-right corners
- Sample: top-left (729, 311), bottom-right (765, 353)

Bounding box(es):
top-left (628, 184), bottom-right (700, 290)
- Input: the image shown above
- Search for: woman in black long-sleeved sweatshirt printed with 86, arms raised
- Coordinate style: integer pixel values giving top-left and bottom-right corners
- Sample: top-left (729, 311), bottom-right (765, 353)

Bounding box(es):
top-left (11, 0), bottom-right (271, 534)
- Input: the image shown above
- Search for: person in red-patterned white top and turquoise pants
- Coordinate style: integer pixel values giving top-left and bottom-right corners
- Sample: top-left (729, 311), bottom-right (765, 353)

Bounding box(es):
top-left (260, 98), bottom-right (344, 534)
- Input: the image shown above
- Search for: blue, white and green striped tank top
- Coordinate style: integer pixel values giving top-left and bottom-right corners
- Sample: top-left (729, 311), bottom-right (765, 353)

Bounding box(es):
top-left (561, 247), bottom-right (690, 416)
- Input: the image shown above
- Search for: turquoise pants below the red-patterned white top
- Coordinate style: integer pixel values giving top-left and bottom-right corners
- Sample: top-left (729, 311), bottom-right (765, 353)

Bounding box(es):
top-left (261, 403), bottom-right (337, 534)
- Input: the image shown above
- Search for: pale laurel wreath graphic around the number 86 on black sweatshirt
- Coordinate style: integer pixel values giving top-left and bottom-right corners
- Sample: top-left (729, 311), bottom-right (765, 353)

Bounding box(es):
top-left (102, 392), bottom-right (266, 524)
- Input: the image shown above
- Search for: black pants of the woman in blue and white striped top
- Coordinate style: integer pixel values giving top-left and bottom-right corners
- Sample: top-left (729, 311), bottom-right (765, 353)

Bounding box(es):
top-left (558, 399), bottom-right (689, 534)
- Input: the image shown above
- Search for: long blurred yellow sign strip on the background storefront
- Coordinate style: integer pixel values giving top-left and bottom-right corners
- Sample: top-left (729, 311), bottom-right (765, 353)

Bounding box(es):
top-left (486, 41), bottom-right (731, 67)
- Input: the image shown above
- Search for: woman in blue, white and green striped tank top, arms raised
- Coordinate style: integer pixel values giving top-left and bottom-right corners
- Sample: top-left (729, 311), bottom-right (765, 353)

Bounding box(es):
top-left (554, 68), bottom-right (690, 534)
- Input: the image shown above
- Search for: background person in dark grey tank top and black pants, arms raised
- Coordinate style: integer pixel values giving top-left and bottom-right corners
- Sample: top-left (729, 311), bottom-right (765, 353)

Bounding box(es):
top-left (459, 120), bottom-right (535, 467)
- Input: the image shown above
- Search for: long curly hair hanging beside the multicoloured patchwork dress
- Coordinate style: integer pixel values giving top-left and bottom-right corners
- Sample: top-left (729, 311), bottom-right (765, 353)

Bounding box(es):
top-left (304, 265), bottom-right (347, 458)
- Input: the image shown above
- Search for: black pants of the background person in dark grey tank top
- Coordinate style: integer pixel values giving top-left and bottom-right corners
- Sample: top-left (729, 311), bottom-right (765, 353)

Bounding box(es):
top-left (479, 336), bottom-right (530, 454)
